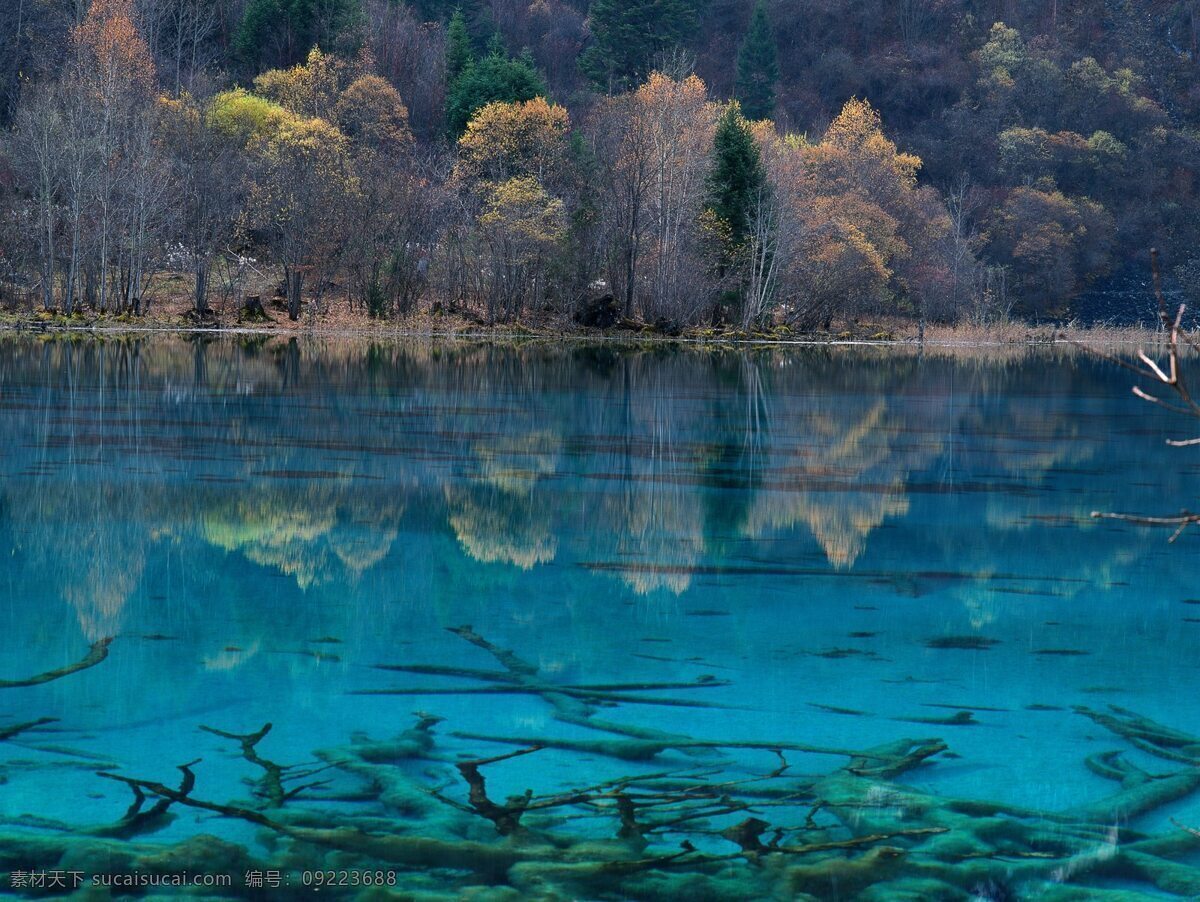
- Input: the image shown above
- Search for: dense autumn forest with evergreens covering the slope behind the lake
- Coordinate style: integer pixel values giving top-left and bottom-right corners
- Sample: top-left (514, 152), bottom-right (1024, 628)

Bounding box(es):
top-left (0, 0), bottom-right (1200, 330)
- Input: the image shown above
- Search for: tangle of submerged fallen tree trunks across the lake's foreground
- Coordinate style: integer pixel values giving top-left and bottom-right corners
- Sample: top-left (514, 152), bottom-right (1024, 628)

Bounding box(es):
top-left (0, 626), bottom-right (1200, 900)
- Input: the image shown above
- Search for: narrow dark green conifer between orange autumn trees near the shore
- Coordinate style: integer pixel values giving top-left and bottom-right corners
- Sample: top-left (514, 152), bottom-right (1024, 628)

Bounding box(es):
top-left (707, 101), bottom-right (767, 252)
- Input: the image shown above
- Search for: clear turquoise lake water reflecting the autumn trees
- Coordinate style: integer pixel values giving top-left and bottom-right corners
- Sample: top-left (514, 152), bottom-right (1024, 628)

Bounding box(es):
top-left (0, 338), bottom-right (1200, 900)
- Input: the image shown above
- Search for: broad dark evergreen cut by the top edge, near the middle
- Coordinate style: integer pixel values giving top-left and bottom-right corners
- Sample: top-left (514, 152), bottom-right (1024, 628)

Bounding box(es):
top-left (580, 0), bottom-right (698, 91)
